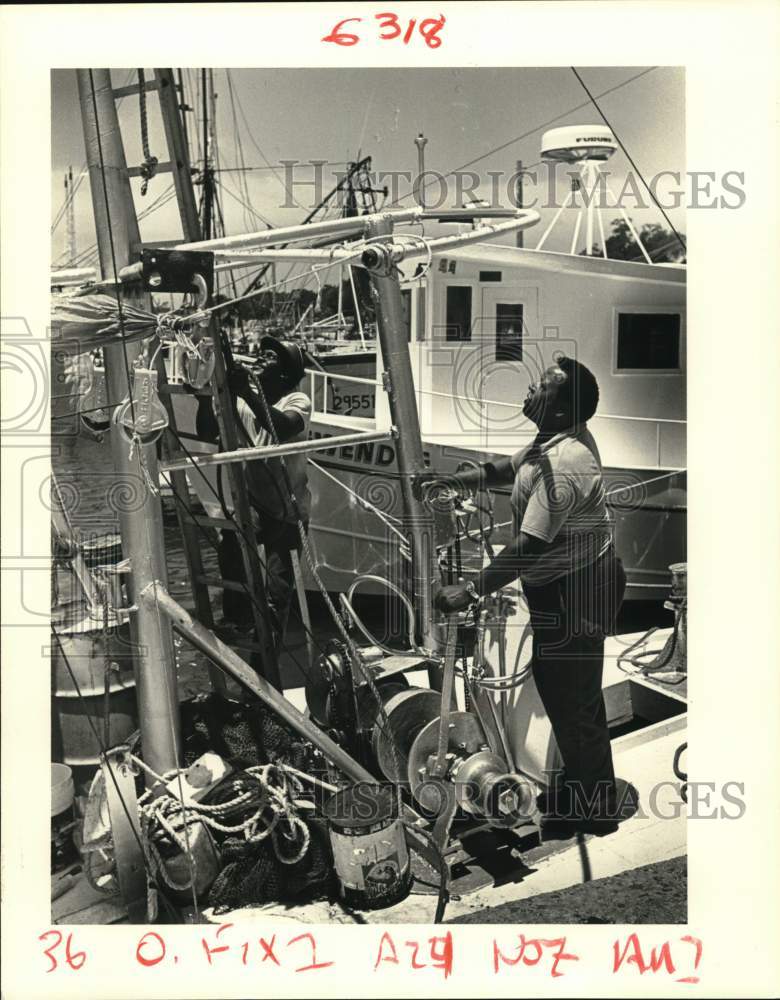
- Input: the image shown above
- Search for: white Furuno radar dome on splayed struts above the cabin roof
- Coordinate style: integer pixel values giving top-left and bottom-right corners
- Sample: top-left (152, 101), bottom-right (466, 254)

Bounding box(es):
top-left (536, 125), bottom-right (653, 264)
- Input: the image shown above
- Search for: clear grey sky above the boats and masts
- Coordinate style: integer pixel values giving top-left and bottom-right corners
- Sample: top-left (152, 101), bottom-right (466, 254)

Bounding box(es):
top-left (51, 66), bottom-right (685, 274)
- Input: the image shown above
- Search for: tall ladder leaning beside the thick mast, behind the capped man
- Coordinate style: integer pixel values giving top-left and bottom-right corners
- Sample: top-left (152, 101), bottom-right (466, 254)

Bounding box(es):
top-left (113, 69), bottom-right (282, 693)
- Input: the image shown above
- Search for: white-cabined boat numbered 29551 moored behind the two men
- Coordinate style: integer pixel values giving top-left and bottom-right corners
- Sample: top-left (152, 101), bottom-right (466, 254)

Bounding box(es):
top-left (264, 126), bottom-right (686, 600)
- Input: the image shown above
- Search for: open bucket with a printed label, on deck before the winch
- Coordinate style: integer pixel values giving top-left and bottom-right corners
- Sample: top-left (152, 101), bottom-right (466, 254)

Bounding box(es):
top-left (324, 782), bottom-right (412, 910)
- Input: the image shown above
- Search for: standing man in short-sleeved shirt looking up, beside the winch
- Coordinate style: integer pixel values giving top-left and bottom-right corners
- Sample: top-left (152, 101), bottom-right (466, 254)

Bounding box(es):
top-left (426, 358), bottom-right (625, 836)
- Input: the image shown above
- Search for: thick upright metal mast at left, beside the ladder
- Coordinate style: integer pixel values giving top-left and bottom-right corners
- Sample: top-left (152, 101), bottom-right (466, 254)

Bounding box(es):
top-left (77, 69), bottom-right (180, 774)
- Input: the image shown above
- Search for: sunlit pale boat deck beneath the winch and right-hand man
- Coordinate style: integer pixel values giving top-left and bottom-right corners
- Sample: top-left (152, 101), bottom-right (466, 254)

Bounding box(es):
top-left (52, 629), bottom-right (687, 924)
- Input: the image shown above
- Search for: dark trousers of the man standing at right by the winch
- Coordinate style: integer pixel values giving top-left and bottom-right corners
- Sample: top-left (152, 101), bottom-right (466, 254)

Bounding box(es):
top-left (523, 547), bottom-right (626, 816)
